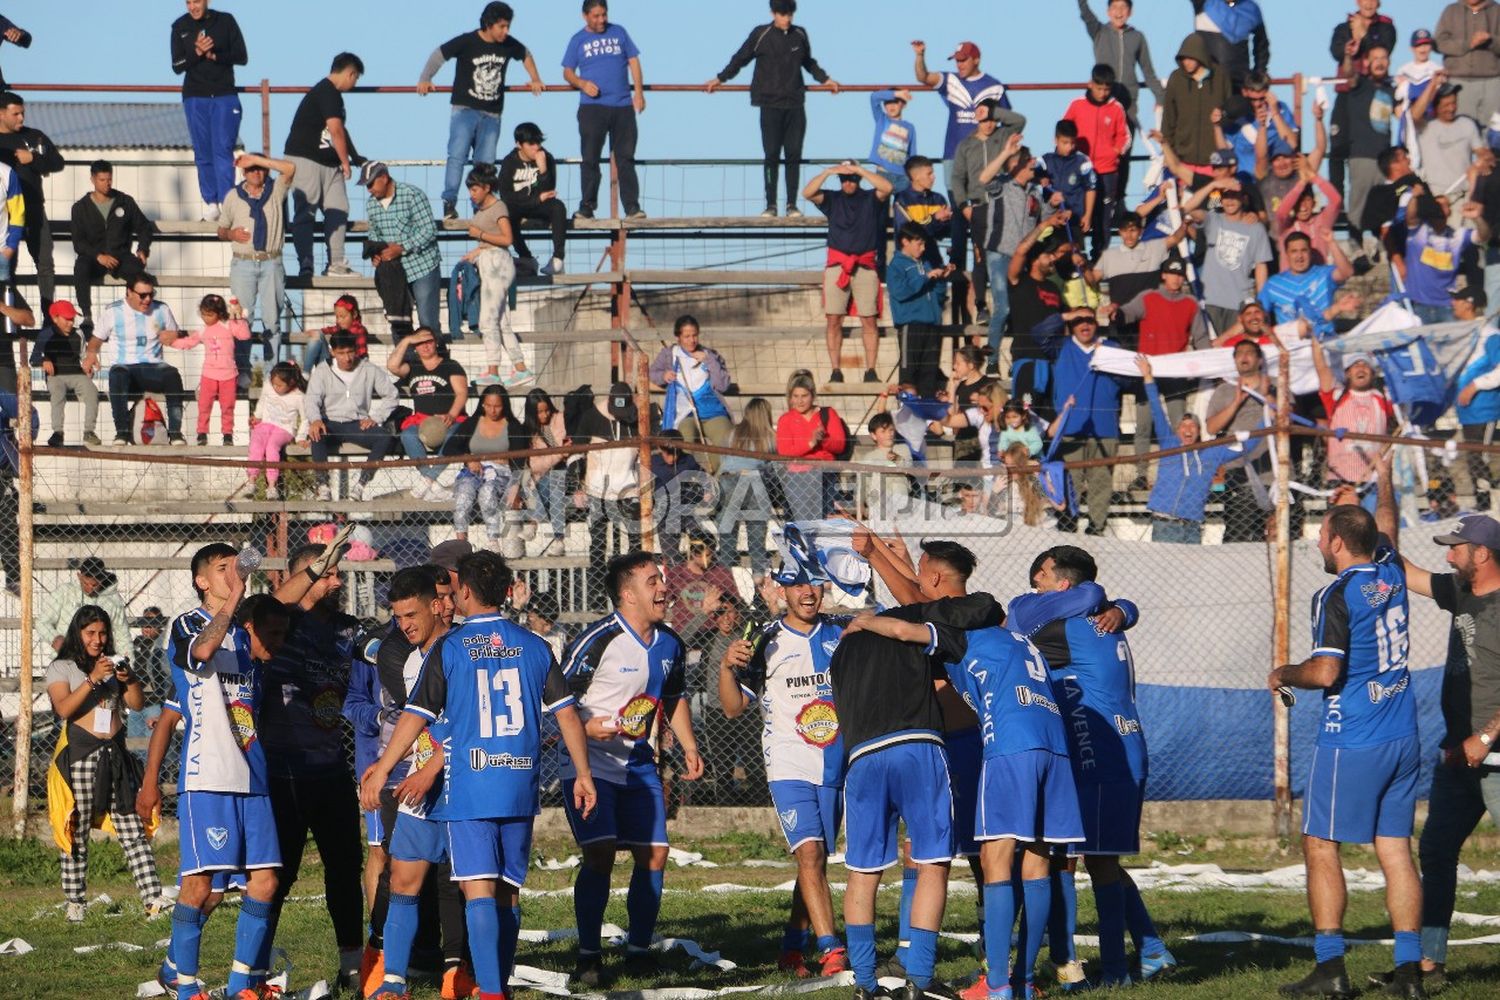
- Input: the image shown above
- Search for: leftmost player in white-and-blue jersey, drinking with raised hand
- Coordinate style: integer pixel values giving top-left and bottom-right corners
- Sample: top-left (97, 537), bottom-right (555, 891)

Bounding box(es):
top-left (157, 543), bottom-right (287, 1000)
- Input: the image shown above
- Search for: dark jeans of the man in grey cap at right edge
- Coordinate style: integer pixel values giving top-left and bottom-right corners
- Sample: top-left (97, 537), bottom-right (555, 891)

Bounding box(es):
top-left (1418, 762), bottom-right (1500, 963)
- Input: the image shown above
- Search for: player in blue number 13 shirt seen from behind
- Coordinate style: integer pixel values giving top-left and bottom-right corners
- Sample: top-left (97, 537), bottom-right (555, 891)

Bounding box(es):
top-left (360, 552), bottom-right (596, 1000)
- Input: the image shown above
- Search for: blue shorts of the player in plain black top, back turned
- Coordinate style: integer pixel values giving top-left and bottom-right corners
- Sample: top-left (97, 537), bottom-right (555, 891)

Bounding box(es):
top-left (845, 742), bottom-right (954, 871)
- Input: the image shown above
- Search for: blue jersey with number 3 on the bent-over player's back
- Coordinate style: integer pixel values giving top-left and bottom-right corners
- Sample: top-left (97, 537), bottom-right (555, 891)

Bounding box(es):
top-left (948, 625), bottom-right (1068, 757)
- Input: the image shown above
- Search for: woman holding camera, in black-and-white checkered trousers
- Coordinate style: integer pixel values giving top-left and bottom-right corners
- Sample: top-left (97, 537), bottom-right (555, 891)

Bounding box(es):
top-left (47, 604), bottom-right (171, 924)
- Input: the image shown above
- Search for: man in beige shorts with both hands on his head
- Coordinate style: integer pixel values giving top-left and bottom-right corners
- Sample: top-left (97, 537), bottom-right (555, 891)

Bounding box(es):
top-left (803, 160), bottom-right (891, 382)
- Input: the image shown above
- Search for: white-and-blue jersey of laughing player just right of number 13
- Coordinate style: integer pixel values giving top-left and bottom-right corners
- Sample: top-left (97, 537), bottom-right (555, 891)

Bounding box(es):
top-left (560, 613), bottom-right (686, 784)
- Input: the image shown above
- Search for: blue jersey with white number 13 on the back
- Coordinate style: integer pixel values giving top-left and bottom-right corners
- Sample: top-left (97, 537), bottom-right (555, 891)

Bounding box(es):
top-left (407, 615), bottom-right (573, 822)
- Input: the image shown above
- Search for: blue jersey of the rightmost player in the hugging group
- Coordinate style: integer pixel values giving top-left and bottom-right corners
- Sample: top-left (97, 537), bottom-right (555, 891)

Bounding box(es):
top-left (1010, 582), bottom-right (1148, 784)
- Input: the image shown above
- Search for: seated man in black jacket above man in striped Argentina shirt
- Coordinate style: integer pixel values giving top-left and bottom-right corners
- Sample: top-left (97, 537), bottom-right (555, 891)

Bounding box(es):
top-left (71, 160), bottom-right (155, 333)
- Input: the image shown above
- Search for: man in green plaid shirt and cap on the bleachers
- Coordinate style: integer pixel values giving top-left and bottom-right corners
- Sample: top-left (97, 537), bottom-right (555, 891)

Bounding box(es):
top-left (360, 160), bottom-right (443, 340)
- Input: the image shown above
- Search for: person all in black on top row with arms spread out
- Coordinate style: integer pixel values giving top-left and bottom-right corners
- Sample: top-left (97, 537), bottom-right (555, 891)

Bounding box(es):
top-left (704, 0), bottom-right (839, 219)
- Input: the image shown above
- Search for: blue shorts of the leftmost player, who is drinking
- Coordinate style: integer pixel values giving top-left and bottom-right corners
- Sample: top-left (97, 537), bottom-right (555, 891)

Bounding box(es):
top-left (177, 792), bottom-right (281, 876)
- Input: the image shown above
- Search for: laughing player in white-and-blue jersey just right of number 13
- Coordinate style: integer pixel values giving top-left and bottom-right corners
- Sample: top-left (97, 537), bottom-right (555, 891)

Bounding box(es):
top-left (563, 552), bottom-right (704, 988)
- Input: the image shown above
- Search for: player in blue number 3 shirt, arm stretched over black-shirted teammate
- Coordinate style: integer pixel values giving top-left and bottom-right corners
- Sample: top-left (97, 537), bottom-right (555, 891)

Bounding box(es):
top-left (855, 615), bottom-right (1083, 1000)
